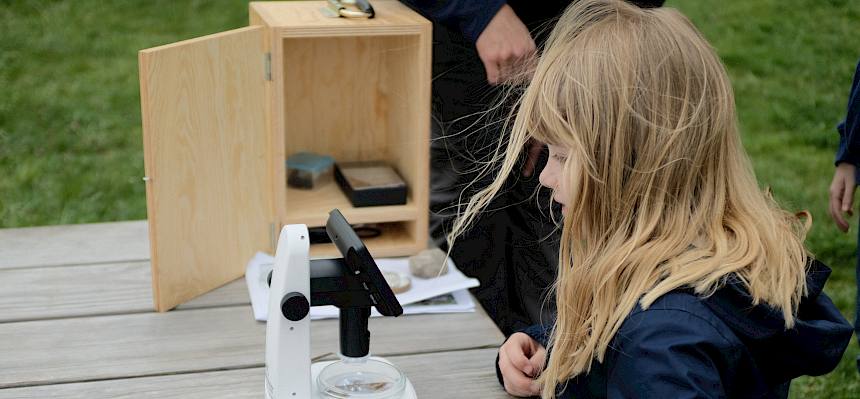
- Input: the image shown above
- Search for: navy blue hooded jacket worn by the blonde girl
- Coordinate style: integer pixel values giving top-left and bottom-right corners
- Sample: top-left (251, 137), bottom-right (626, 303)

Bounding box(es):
top-left (496, 261), bottom-right (852, 398)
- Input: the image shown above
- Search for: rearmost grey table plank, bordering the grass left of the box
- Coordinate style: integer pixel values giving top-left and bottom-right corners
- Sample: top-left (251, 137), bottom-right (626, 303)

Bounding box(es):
top-left (0, 220), bottom-right (149, 269)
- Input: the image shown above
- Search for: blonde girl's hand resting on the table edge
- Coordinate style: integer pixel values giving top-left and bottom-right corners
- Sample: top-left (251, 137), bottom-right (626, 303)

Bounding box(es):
top-left (499, 333), bottom-right (546, 396)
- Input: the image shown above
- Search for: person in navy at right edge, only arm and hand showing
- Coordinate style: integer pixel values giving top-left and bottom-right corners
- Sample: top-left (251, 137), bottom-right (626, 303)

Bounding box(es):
top-left (830, 62), bottom-right (860, 371)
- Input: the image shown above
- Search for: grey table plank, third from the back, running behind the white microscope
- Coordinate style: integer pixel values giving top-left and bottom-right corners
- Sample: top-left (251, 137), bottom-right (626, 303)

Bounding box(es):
top-left (0, 306), bottom-right (503, 388)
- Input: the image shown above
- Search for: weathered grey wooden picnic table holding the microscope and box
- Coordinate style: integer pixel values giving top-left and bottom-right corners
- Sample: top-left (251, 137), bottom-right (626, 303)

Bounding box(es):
top-left (0, 221), bottom-right (508, 399)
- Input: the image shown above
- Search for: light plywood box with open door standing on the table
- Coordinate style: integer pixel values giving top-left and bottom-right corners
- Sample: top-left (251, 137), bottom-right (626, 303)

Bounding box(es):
top-left (139, 0), bottom-right (431, 311)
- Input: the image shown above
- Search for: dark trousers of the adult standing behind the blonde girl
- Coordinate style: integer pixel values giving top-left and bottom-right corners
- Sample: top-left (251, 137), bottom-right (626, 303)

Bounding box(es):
top-left (430, 24), bottom-right (559, 335)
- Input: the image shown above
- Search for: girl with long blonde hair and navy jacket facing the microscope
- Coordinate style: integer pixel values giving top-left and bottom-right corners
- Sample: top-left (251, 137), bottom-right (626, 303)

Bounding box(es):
top-left (451, 0), bottom-right (851, 398)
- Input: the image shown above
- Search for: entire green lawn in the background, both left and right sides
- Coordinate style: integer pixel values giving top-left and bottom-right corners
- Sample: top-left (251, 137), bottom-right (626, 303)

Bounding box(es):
top-left (0, 0), bottom-right (860, 398)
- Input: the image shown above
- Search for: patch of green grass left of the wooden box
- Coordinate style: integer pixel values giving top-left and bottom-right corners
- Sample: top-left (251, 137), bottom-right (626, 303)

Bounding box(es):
top-left (0, 0), bottom-right (248, 227)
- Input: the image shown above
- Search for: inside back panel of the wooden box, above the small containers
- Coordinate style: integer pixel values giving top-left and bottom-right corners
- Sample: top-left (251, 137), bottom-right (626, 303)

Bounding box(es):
top-left (283, 35), bottom-right (410, 163)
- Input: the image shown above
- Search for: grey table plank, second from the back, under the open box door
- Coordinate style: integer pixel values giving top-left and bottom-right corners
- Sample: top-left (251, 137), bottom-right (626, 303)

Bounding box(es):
top-left (0, 261), bottom-right (251, 323)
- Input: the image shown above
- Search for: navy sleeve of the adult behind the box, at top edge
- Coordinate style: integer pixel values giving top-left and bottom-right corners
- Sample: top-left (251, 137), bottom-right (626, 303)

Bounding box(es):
top-left (400, 0), bottom-right (506, 43)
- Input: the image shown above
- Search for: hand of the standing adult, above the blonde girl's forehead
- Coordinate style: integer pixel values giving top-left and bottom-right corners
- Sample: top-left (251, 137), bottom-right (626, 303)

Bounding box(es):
top-left (475, 4), bottom-right (535, 85)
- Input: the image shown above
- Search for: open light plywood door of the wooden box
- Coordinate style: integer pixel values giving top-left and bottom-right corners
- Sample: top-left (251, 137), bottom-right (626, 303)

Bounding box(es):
top-left (139, 27), bottom-right (277, 311)
